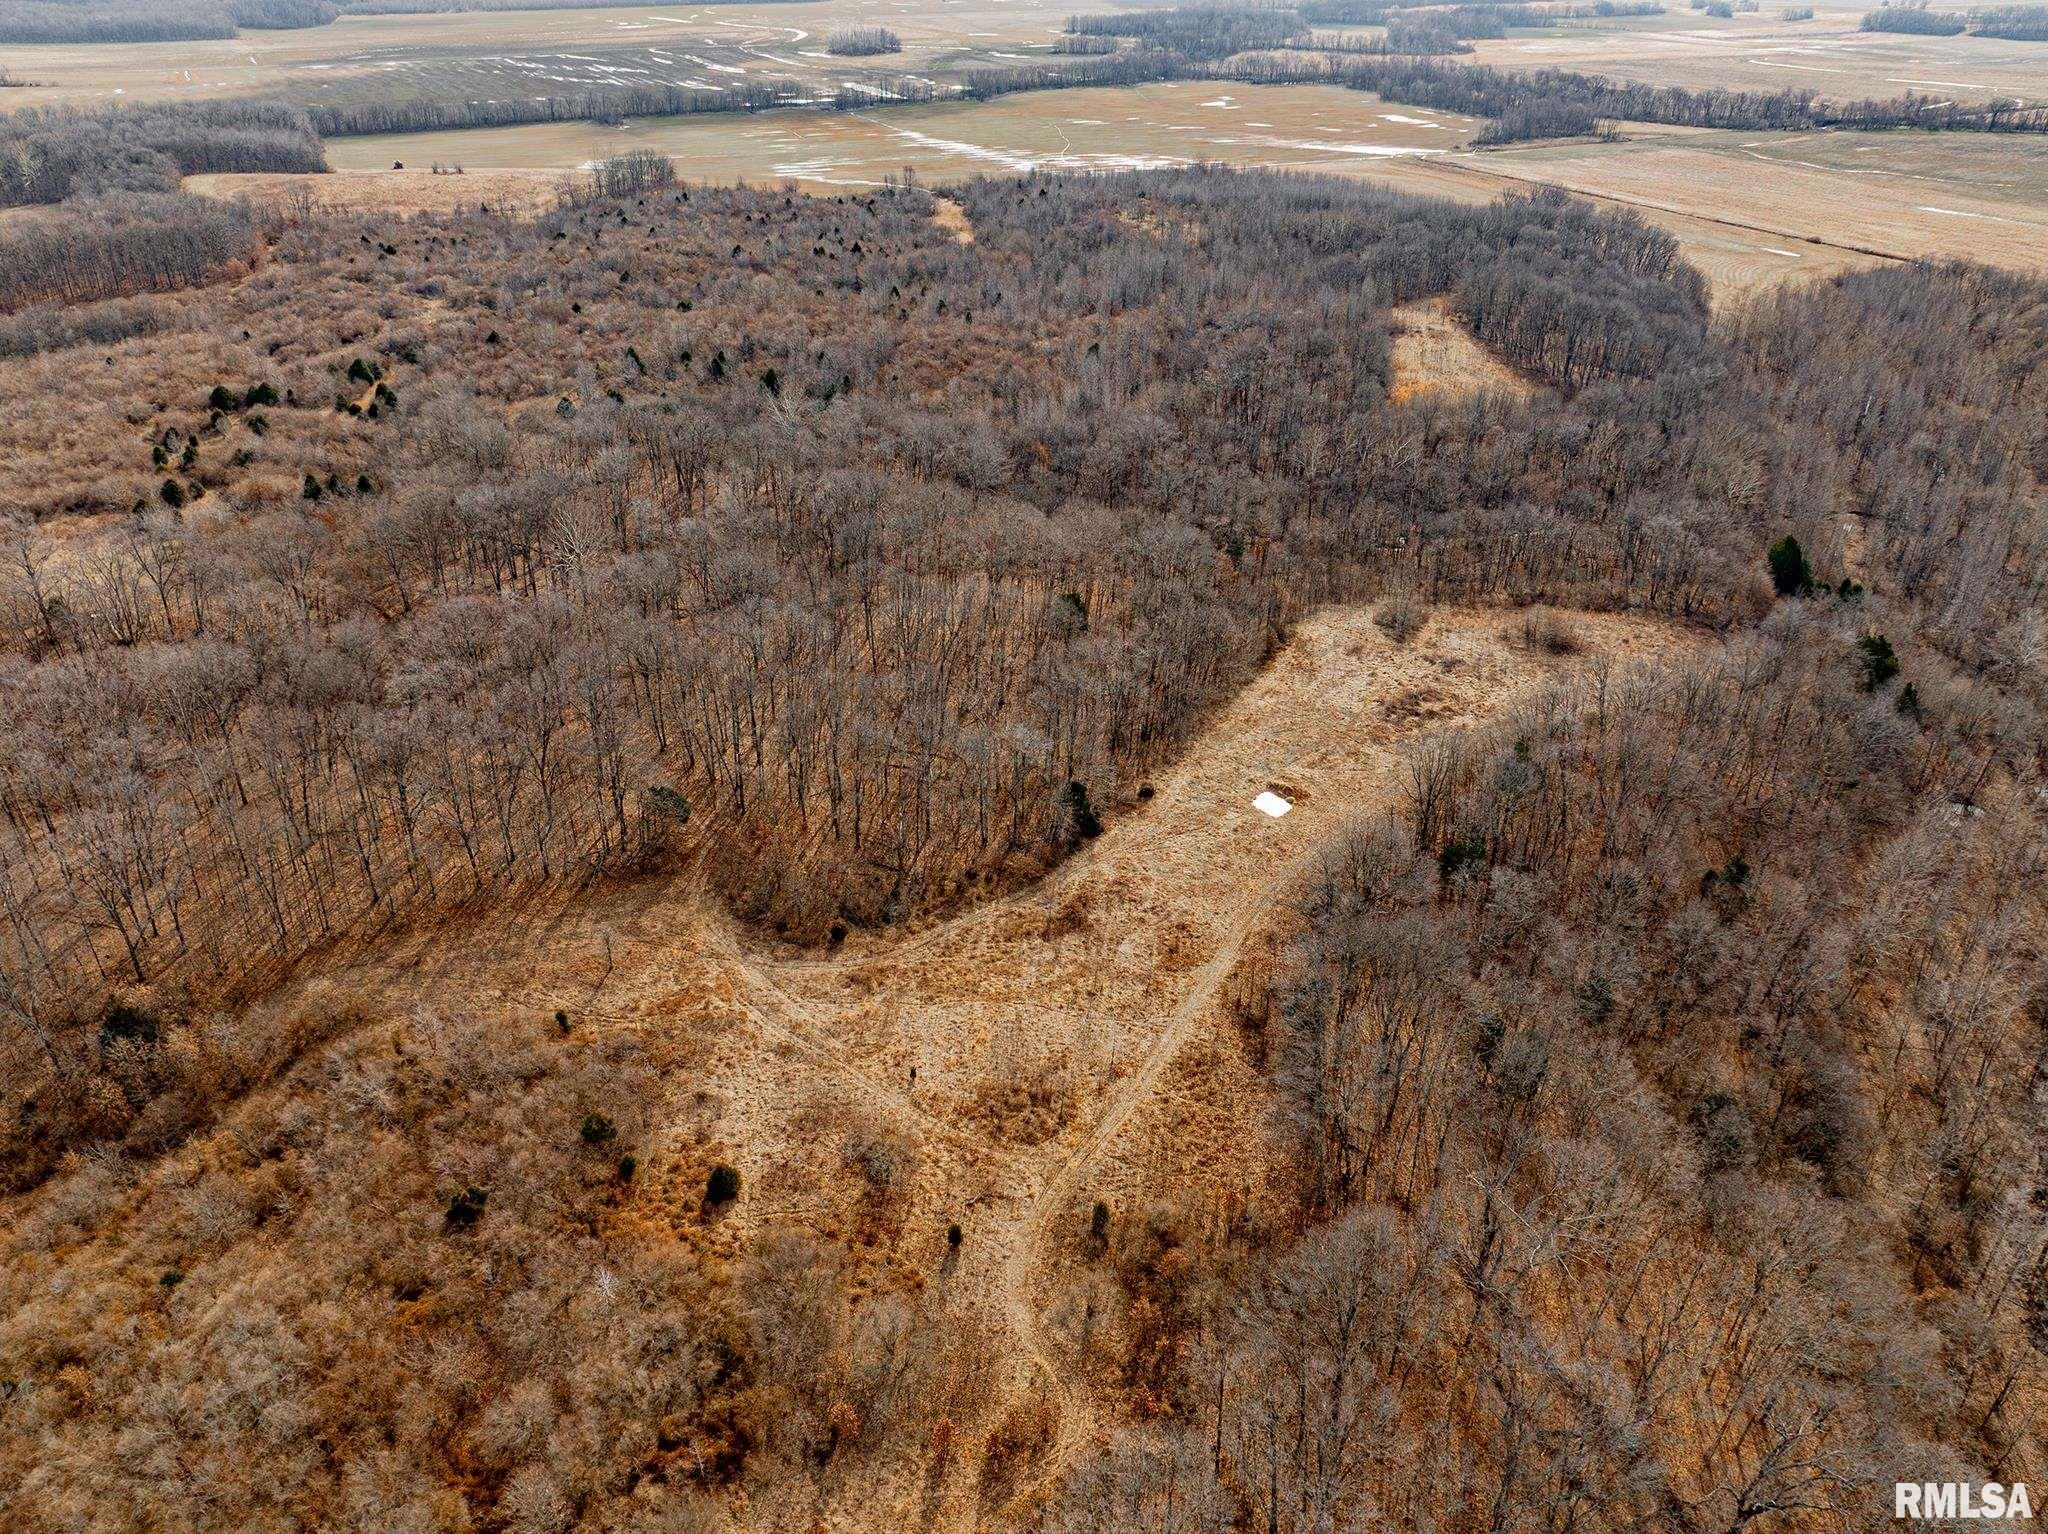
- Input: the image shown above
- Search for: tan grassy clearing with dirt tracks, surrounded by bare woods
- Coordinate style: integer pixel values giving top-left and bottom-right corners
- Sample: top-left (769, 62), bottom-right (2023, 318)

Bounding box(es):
top-left (296, 608), bottom-right (1690, 1530)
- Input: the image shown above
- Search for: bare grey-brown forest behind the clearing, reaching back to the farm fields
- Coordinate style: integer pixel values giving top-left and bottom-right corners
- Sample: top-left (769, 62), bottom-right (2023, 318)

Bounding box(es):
top-left (0, 155), bottom-right (2042, 1163)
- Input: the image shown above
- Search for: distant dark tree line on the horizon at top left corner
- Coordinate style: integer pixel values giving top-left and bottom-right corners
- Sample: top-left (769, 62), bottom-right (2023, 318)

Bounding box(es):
top-left (0, 0), bottom-right (798, 45)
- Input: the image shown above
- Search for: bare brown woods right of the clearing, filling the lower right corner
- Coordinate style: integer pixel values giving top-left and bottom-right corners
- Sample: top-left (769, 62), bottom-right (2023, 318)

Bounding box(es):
top-left (1097, 606), bottom-right (2048, 1534)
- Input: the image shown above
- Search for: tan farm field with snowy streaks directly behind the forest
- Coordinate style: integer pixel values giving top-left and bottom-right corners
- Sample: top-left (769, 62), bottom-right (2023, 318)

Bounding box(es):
top-left (299, 82), bottom-right (2048, 293)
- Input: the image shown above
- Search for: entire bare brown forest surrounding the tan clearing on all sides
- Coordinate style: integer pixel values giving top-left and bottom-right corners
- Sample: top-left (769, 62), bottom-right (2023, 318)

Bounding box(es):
top-left (0, 107), bottom-right (2048, 1534)
